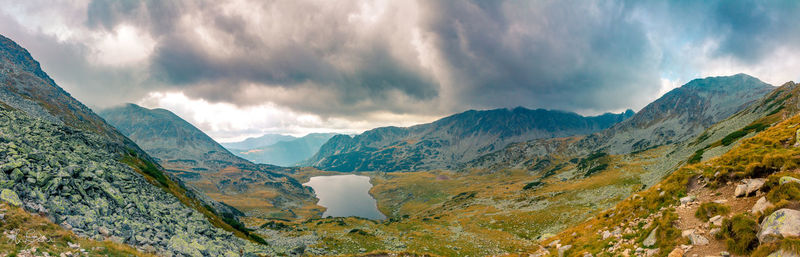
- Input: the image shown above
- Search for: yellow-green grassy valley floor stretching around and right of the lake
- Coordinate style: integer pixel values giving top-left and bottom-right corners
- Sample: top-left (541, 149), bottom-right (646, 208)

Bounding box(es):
top-left (234, 144), bottom-right (674, 256)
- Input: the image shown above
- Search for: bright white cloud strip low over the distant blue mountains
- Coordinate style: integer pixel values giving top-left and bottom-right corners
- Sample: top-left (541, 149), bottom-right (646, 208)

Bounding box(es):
top-left (138, 92), bottom-right (439, 142)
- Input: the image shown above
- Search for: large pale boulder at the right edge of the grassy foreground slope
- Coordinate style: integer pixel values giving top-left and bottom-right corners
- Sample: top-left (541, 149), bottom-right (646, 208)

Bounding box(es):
top-left (758, 209), bottom-right (800, 243)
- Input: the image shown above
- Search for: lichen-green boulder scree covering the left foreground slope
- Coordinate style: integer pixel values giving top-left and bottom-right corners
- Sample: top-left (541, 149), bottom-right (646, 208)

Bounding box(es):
top-left (0, 110), bottom-right (268, 256)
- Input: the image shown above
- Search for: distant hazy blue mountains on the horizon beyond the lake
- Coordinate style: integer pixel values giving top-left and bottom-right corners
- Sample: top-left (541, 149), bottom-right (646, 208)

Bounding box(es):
top-left (223, 133), bottom-right (336, 166)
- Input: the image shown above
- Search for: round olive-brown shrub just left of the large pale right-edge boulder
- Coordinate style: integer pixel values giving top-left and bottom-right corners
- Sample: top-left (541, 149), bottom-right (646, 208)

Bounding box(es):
top-left (720, 214), bottom-right (758, 255)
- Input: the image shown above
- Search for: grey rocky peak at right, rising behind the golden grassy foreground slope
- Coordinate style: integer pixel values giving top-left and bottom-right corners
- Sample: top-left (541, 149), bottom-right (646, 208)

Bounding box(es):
top-left (597, 74), bottom-right (775, 153)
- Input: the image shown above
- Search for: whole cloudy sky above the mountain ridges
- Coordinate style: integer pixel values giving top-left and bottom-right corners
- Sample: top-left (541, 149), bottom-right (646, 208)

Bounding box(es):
top-left (0, 0), bottom-right (800, 142)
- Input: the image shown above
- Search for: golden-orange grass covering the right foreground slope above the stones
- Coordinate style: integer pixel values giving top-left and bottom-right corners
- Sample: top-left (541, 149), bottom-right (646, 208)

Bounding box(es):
top-left (543, 113), bottom-right (800, 256)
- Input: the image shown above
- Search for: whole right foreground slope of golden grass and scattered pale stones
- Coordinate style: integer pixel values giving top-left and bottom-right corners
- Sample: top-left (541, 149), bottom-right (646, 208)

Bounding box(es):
top-left (548, 96), bottom-right (800, 256)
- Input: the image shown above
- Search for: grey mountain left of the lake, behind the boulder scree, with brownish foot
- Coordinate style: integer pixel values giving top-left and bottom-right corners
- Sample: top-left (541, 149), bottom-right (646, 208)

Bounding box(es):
top-left (100, 104), bottom-right (316, 219)
